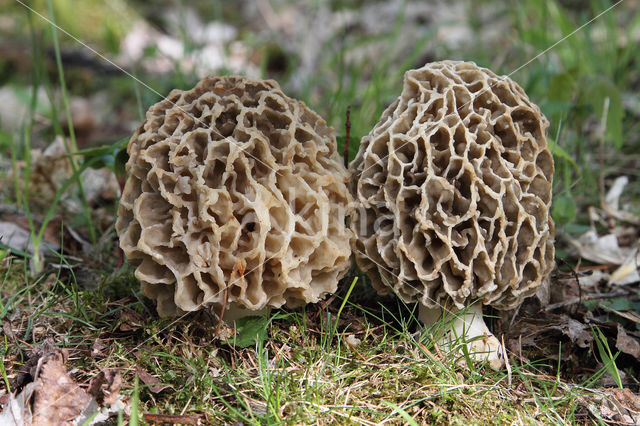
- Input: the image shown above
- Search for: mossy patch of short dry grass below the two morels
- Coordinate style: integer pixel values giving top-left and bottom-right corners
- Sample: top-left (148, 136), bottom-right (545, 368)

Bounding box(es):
top-left (0, 259), bottom-right (608, 424)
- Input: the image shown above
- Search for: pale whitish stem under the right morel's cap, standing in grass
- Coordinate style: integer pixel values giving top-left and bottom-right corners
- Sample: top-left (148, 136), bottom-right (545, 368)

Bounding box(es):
top-left (418, 303), bottom-right (504, 370)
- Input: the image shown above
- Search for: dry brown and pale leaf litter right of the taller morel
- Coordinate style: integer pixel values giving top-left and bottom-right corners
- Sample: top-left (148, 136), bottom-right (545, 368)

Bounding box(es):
top-left (498, 176), bottom-right (640, 424)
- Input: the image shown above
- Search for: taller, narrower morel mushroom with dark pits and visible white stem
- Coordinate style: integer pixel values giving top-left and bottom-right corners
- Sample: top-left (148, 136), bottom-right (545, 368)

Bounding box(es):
top-left (350, 61), bottom-right (554, 368)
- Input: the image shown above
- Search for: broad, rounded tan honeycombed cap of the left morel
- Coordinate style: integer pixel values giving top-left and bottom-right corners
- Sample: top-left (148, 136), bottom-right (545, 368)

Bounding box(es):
top-left (116, 77), bottom-right (353, 318)
